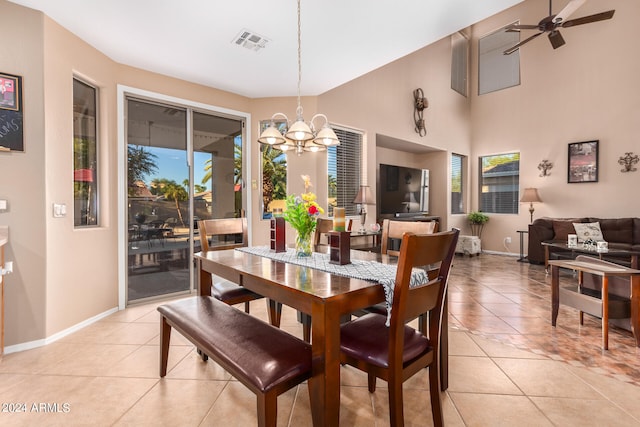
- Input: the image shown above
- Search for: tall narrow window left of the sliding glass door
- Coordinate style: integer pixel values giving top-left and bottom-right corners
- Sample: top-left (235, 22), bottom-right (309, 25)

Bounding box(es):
top-left (73, 79), bottom-right (98, 227)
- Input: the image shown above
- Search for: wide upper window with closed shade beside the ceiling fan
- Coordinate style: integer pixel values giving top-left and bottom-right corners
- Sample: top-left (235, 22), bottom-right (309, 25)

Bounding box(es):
top-left (478, 29), bottom-right (520, 95)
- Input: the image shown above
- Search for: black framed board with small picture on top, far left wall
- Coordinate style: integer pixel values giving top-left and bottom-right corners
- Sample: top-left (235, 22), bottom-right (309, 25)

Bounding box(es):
top-left (0, 73), bottom-right (24, 151)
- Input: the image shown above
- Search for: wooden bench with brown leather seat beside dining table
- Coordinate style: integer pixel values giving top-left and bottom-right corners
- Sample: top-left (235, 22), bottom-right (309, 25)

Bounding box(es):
top-left (158, 296), bottom-right (311, 426)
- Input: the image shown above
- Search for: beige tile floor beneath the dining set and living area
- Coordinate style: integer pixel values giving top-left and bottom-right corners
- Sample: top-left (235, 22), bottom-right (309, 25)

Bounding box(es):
top-left (0, 254), bottom-right (640, 427)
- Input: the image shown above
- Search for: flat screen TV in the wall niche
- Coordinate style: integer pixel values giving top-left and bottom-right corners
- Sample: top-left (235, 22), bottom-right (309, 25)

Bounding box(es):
top-left (378, 164), bottom-right (429, 216)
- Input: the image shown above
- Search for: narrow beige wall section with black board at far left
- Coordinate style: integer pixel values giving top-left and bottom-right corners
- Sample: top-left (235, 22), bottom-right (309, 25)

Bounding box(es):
top-left (0, 0), bottom-right (48, 345)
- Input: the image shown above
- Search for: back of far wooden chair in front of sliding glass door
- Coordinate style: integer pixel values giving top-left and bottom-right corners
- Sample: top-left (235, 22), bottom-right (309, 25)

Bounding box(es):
top-left (198, 218), bottom-right (249, 252)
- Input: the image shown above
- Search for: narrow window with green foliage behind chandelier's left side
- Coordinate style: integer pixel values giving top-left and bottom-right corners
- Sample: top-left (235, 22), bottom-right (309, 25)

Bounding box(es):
top-left (258, 120), bottom-right (287, 219)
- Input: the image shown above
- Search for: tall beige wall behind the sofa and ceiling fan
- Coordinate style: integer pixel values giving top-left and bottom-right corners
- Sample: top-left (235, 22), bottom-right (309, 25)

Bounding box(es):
top-left (471, 0), bottom-right (640, 252)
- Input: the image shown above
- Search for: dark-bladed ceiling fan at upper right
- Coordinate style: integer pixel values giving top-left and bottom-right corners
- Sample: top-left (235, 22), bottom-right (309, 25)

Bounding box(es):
top-left (504, 0), bottom-right (615, 55)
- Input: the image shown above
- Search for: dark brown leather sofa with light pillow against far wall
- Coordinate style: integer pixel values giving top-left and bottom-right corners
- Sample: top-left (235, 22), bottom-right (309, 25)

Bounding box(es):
top-left (527, 217), bottom-right (640, 266)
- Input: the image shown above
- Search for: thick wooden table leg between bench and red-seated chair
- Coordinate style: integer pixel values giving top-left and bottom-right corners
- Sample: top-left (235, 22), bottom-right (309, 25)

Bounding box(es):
top-left (308, 304), bottom-right (340, 427)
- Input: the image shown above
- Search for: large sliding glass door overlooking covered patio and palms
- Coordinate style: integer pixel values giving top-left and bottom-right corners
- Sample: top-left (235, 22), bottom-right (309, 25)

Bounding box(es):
top-left (127, 98), bottom-right (245, 303)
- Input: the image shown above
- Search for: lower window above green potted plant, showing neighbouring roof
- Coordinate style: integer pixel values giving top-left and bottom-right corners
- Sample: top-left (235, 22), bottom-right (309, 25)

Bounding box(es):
top-left (479, 153), bottom-right (520, 214)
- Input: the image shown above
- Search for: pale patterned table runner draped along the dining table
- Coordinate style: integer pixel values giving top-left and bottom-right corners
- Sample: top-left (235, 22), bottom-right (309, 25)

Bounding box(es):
top-left (236, 246), bottom-right (429, 326)
